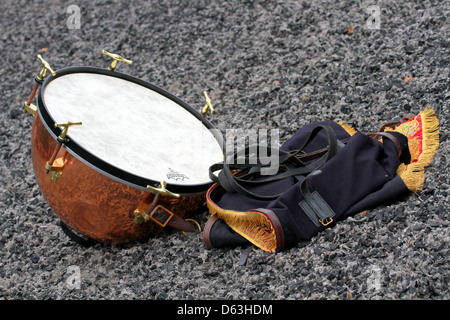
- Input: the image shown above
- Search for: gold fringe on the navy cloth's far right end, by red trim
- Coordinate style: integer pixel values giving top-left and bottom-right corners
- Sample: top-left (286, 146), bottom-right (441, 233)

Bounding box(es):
top-left (394, 106), bottom-right (439, 191)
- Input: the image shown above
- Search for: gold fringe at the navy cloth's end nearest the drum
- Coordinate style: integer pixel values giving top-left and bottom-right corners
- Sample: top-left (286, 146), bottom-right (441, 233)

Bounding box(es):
top-left (207, 199), bottom-right (277, 252)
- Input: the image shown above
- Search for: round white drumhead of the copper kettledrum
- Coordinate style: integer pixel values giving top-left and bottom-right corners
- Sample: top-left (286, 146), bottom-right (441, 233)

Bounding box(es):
top-left (43, 73), bottom-right (223, 185)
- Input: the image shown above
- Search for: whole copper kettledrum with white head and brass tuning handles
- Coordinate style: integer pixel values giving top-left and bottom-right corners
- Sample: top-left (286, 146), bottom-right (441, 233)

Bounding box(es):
top-left (24, 50), bottom-right (224, 244)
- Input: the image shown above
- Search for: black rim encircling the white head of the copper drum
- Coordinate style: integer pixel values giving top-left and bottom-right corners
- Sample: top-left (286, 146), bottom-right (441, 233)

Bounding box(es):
top-left (37, 67), bottom-right (224, 196)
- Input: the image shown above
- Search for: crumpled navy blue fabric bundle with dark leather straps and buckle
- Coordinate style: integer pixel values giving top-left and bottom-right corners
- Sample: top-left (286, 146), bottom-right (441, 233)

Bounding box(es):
top-left (203, 121), bottom-right (411, 252)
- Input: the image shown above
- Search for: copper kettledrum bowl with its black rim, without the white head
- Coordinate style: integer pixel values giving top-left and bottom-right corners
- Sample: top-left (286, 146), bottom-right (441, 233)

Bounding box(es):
top-left (27, 67), bottom-right (220, 244)
